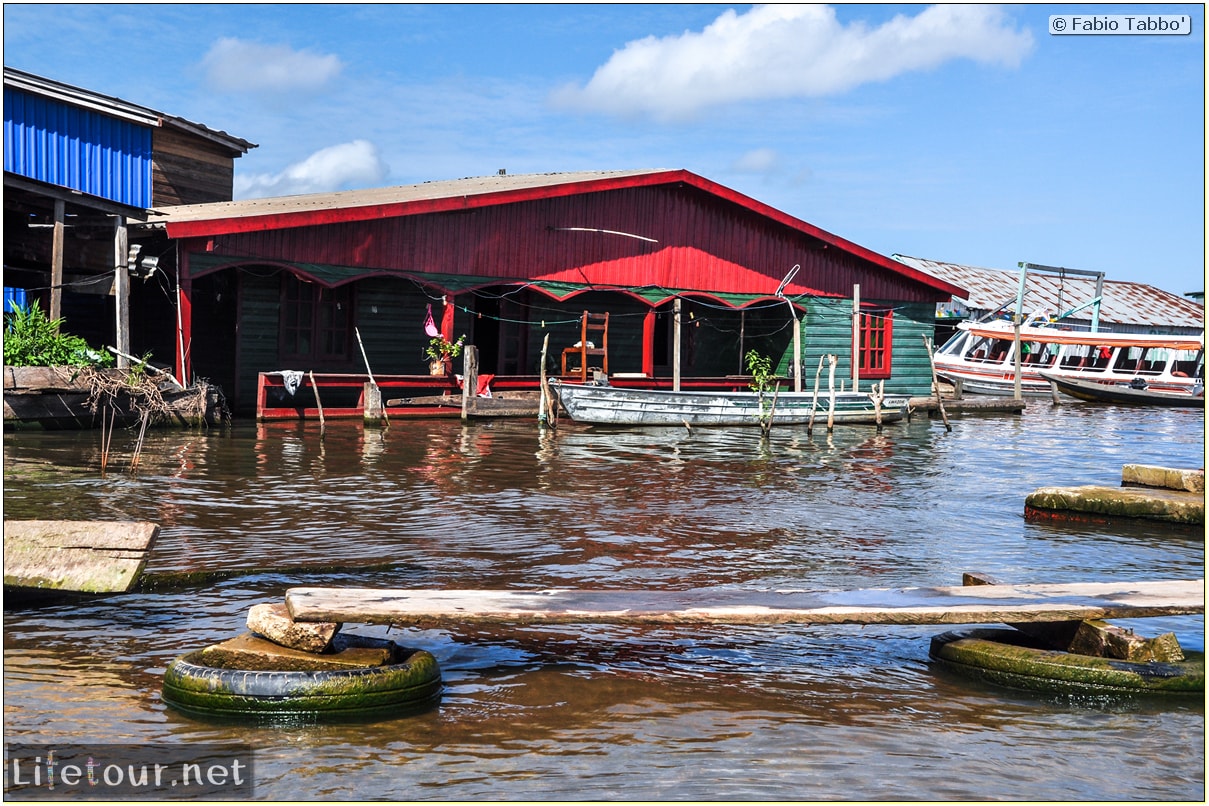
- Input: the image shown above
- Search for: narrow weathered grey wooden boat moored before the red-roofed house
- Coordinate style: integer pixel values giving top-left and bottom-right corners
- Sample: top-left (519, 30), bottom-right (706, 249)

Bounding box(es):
top-left (550, 379), bottom-right (907, 425)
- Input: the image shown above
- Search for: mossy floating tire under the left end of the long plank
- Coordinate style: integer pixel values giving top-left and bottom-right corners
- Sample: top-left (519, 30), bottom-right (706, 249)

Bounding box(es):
top-left (163, 648), bottom-right (441, 720)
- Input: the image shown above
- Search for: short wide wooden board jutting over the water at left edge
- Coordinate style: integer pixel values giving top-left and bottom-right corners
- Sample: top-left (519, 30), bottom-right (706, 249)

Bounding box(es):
top-left (4, 521), bottom-right (160, 593)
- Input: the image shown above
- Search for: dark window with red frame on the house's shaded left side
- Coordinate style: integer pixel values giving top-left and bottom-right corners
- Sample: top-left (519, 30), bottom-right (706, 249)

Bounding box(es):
top-left (280, 274), bottom-right (352, 364)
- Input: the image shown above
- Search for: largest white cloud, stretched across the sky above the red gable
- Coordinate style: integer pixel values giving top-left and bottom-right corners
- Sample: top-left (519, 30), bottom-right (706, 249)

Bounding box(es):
top-left (554, 5), bottom-right (1032, 120)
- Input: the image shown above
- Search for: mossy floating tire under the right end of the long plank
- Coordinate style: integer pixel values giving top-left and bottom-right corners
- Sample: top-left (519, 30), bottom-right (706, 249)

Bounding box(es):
top-left (929, 628), bottom-right (1205, 696)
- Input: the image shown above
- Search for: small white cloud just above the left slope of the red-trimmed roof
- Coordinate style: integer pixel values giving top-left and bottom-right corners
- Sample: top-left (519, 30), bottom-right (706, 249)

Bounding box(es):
top-left (235, 140), bottom-right (388, 198)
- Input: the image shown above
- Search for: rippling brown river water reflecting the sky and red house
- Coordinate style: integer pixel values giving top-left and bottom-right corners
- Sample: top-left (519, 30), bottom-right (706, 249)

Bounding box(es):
top-left (4, 401), bottom-right (1205, 801)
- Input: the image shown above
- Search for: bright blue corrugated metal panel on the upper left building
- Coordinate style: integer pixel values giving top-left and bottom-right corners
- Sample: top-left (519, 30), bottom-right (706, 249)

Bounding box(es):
top-left (4, 87), bottom-right (152, 208)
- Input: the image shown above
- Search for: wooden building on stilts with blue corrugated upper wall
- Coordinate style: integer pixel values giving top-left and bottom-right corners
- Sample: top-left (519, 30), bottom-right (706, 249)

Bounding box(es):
top-left (4, 68), bottom-right (255, 358)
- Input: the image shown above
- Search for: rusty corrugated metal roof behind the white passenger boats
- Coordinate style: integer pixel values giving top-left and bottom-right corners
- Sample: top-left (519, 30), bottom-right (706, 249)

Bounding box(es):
top-left (892, 255), bottom-right (1205, 329)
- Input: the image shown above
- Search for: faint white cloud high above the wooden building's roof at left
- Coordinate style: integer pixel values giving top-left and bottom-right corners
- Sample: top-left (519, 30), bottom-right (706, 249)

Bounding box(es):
top-left (202, 37), bottom-right (345, 93)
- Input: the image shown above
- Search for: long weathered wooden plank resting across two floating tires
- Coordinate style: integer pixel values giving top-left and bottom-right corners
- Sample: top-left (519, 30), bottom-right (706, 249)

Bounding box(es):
top-left (285, 579), bottom-right (1204, 625)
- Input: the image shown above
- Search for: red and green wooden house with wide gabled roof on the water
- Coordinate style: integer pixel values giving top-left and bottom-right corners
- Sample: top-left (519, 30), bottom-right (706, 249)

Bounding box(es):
top-left (141, 170), bottom-right (961, 413)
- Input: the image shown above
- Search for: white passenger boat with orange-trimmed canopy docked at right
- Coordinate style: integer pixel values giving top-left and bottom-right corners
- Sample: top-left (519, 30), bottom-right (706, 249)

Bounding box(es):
top-left (936, 314), bottom-right (1204, 395)
